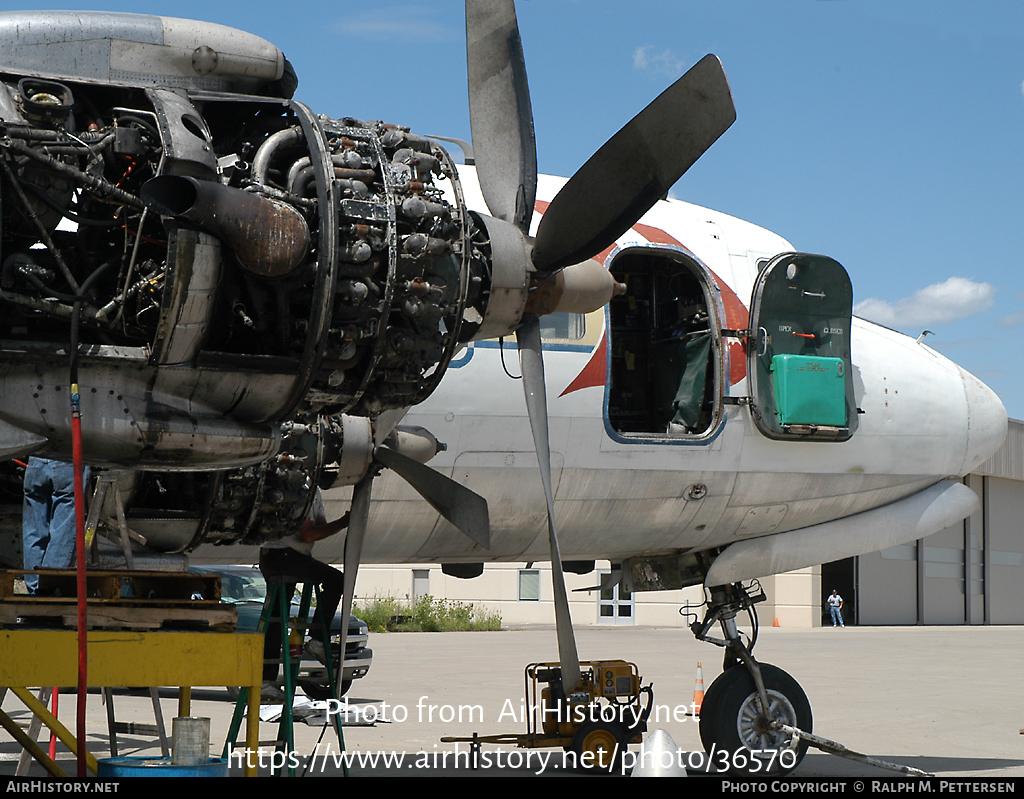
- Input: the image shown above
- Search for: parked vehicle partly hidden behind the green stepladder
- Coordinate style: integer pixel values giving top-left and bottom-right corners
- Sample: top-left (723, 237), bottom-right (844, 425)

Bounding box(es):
top-left (188, 565), bottom-right (374, 700)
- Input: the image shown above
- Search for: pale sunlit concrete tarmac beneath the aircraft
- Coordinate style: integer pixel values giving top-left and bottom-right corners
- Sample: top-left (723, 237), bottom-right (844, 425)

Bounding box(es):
top-left (0, 626), bottom-right (1024, 780)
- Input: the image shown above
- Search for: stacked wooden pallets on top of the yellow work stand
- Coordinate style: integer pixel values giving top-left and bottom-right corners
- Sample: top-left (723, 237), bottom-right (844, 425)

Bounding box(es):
top-left (0, 569), bottom-right (238, 632)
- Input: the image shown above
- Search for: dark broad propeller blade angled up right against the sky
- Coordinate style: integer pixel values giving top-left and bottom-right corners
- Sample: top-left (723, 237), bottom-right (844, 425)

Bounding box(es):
top-left (528, 55), bottom-right (736, 271)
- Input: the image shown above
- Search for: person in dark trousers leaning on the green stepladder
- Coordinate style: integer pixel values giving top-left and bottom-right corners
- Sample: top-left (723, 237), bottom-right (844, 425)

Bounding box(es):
top-left (259, 489), bottom-right (348, 680)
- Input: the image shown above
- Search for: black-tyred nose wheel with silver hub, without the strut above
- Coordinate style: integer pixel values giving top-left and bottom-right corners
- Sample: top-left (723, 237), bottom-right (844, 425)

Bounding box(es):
top-left (700, 663), bottom-right (812, 776)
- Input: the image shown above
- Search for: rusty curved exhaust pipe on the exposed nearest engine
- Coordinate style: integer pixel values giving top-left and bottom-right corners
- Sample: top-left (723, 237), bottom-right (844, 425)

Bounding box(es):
top-left (140, 175), bottom-right (309, 278)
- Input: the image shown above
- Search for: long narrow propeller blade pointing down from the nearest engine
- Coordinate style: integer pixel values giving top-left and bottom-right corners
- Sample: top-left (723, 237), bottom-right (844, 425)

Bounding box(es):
top-left (515, 317), bottom-right (580, 695)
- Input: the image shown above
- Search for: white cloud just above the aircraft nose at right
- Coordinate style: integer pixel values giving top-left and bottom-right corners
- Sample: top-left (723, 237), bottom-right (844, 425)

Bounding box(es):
top-left (853, 278), bottom-right (995, 328)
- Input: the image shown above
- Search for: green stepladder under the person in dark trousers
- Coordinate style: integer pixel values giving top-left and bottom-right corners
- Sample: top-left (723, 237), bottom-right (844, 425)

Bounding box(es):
top-left (221, 579), bottom-right (349, 776)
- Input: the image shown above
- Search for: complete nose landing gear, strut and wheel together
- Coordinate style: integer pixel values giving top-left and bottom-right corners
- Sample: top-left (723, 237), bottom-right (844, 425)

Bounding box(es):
top-left (690, 583), bottom-right (812, 775)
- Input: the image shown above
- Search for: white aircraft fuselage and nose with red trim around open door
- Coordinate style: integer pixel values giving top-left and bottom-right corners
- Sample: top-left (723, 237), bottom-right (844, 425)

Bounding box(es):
top-left (318, 169), bottom-right (1006, 563)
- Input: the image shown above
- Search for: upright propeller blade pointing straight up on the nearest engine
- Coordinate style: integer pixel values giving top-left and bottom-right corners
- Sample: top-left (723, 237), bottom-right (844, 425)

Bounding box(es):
top-left (466, 0), bottom-right (537, 233)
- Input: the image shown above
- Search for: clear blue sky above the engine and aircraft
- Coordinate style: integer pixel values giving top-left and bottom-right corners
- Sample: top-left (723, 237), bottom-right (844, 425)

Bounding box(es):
top-left (9, 0), bottom-right (1024, 419)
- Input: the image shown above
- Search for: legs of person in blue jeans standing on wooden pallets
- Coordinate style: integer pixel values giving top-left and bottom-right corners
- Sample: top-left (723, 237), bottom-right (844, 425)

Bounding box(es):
top-left (22, 458), bottom-right (89, 594)
